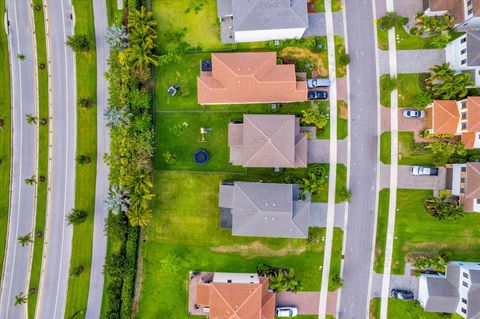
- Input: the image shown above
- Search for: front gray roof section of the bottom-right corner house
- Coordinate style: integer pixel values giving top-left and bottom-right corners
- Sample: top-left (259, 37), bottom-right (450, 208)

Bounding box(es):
top-left (425, 277), bottom-right (459, 313)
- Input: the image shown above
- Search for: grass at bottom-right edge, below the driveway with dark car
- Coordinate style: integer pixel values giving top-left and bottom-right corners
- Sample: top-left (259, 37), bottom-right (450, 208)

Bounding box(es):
top-left (370, 298), bottom-right (462, 319)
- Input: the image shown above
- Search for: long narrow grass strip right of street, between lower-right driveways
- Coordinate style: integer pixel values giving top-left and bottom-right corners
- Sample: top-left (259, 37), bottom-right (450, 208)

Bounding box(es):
top-left (373, 188), bottom-right (390, 274)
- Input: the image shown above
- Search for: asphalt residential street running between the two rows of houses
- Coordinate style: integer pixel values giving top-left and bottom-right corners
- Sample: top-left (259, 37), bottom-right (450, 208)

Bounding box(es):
top-left (339, 0), bottom-right (378, 319)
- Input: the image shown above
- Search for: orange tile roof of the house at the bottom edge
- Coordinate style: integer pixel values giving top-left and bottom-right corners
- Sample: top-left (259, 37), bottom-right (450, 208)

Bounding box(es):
top-left (196, 278), bottom-right (275, 319)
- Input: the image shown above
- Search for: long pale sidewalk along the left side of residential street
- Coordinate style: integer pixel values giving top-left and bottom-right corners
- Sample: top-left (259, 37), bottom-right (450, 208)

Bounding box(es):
top-left (318, 0), bottom-right (343, 319)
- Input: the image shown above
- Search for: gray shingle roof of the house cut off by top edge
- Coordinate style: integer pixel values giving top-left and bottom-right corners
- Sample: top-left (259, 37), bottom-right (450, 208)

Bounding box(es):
top-left (222, 0), bottom-right (308, 31)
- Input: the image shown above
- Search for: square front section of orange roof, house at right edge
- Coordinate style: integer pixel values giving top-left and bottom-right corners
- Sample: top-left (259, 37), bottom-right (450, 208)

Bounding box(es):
top-left (433, 100), bottom-right (460, 134)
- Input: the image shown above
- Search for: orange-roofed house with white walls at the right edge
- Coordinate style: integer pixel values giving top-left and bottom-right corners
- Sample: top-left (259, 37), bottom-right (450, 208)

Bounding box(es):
top-left (425, 96), bottom-right (480, 149)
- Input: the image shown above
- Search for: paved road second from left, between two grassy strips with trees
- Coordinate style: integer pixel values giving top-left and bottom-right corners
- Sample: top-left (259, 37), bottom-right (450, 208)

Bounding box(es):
top-left (36, 0), bottom-right (76, 319)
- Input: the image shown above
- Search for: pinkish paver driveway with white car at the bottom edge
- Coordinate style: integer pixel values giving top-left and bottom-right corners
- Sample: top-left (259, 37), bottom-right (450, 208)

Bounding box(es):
top-left (276, 291), bottom-right (337, 316)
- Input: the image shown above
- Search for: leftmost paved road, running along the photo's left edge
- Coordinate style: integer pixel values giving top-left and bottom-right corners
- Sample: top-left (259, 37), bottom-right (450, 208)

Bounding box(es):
top-left (0, 0), bottom-right (37, 318)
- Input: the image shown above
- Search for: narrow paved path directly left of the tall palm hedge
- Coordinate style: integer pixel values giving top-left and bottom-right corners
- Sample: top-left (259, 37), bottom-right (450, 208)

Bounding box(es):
top-left (86, 1), bottom-right (110, 319)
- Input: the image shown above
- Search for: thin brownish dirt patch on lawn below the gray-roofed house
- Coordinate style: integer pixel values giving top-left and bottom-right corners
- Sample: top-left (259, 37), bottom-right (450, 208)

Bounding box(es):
top-left (210, 241), bottom-right (306, 259)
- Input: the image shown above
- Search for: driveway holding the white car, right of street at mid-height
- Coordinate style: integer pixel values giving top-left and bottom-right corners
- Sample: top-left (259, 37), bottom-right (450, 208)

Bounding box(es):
top-left (380, 164), bottom-right (447, 193)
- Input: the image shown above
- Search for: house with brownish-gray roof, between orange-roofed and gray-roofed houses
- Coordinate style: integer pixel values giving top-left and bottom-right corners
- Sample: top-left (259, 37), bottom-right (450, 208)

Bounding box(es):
top-left (228, 114), bottom-right (308, 168)
